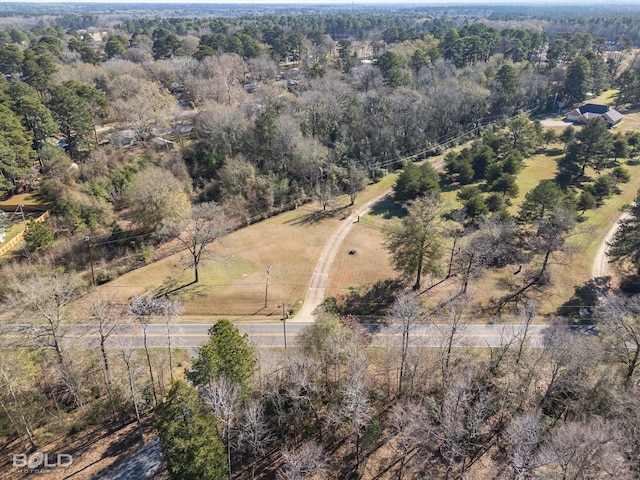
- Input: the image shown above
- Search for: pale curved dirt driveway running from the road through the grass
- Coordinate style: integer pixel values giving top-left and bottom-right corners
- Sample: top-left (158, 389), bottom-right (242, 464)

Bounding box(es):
top-left (294, 191), bottom-right (389, 322)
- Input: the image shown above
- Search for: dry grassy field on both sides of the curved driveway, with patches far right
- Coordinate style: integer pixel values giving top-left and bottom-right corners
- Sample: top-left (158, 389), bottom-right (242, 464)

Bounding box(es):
top-left (100, 105), bottom-right (640, 321)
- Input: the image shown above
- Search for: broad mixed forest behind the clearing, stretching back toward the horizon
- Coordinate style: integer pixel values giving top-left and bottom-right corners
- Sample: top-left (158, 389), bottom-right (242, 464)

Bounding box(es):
top-left (0, 7), bottom-right (628, 244)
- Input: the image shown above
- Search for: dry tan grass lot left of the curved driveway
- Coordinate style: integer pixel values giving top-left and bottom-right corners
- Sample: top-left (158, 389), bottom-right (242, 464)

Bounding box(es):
top-left (102, 205), bottom-right (340, 316)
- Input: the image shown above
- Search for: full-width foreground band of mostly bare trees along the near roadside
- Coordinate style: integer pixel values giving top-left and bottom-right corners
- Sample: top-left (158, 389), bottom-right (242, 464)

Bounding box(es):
top-left (0, 262), bottom-right (640, 479)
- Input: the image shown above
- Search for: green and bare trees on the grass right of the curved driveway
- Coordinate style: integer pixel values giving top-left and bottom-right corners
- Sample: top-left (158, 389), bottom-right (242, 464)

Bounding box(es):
top-left (380, 113), bottom-right (638, 314)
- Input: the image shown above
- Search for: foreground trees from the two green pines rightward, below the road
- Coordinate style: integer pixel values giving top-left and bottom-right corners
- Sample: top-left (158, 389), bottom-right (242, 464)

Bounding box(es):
top-left (156, 300), bottom-right (640, 480)
